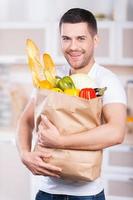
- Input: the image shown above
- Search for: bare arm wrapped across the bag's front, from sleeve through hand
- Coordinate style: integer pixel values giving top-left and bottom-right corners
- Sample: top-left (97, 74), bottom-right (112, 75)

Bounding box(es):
top-left (40, 103), bottom-right (126, 150)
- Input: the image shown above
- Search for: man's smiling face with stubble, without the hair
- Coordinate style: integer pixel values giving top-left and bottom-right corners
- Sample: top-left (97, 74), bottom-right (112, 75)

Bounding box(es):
top-left (60, 22), bottom-right (96, 69)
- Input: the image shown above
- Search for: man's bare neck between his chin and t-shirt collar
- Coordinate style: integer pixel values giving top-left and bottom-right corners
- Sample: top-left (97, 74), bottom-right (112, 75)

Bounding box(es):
top-left (70, 59), bottom-right (95, 74)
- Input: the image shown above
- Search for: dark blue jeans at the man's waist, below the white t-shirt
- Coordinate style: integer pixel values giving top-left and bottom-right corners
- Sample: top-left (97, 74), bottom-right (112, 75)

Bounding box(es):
top-left (35, 191), bottom-right (105, 200)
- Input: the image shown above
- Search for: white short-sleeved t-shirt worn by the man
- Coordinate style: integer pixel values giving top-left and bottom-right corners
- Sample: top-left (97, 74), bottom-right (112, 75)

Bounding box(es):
top-left (33, 63), bottom-right (126, 196)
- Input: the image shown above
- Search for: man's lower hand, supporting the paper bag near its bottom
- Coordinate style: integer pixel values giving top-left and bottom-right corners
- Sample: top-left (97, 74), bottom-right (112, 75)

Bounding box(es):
top-left (21, 149), bottom-right (61, 178)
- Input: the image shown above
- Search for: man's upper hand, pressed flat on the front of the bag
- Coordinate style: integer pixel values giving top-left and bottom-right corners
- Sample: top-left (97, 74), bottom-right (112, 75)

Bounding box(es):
top-left (38, 115), bottom-right (62, 148)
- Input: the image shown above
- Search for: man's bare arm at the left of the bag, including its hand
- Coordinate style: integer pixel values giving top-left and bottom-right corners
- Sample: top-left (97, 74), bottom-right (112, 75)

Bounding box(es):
top-left (16, 99), bottom-right (61, 177)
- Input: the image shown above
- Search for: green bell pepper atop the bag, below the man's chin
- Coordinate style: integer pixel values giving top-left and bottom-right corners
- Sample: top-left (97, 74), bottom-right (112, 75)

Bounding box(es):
top-left (57, 76), bottom-right (75, 91)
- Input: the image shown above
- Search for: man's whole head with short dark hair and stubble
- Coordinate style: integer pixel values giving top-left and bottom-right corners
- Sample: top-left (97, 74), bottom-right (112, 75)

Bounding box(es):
top-left (59, 8), bottom-right (97, 70)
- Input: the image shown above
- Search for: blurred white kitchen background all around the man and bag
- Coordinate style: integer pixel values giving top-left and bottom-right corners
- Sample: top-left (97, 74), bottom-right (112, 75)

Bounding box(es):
top-left (0, 0), bottom-right (133, 200)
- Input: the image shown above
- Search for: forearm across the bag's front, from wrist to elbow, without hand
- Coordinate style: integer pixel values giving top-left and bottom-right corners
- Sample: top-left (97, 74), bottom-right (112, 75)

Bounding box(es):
top-left (61, 124), bottom-right (124, 150)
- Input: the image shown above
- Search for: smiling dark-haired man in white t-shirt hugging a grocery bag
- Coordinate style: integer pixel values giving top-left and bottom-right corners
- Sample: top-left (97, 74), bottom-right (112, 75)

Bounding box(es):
top-left (17, 8), bottom-right (126, 200)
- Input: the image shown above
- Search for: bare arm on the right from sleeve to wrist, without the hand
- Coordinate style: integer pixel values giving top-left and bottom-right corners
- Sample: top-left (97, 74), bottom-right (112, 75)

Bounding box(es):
top-left (62, 103), bottom-right (126, 150)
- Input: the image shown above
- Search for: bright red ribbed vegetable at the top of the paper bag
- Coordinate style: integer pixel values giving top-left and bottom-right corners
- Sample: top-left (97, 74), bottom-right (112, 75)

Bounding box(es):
top-left (79, 88), bottom-right (96, 99)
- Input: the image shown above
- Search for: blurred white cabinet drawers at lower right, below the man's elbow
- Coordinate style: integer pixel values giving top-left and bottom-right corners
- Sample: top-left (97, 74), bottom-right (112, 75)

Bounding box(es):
top-left (103, 145), bottom-right (133, 200)
